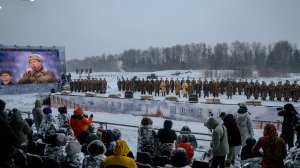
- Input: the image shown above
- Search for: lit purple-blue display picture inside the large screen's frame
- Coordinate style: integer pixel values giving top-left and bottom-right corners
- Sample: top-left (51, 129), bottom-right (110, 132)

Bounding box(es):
top-left (0, 50), bottom-right (61, 84)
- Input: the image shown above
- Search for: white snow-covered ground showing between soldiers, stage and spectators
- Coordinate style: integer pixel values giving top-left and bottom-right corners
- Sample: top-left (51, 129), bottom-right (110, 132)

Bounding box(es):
top-left (0, 70), bottom-right (300, 163)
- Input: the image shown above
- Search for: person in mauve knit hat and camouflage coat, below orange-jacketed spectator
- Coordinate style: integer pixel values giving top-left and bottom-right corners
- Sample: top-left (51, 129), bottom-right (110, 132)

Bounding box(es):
top-left (44, 133), bottom-right (69, 162)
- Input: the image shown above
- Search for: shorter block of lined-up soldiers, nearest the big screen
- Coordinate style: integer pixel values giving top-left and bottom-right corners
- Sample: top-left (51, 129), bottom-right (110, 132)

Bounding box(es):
top-left (70, 78), bottom-right (107, 93)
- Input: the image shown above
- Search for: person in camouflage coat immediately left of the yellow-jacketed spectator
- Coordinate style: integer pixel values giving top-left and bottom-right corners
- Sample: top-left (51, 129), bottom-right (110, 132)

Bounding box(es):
top-left (82, 140), bottom-right (106, 168)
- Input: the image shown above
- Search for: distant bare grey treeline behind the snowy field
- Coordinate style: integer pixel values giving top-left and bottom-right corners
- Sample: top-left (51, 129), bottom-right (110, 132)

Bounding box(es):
top-left (67, 41), bottom-right (300, 76)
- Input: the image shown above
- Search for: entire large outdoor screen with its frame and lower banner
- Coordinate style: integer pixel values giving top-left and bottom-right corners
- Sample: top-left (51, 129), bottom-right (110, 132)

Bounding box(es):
top-left (0, 46), bottom-right (65, 94)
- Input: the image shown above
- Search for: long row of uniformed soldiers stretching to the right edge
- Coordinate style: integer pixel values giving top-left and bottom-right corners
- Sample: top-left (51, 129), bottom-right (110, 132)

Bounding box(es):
top-left (117, 78), bottom-right (300, 102)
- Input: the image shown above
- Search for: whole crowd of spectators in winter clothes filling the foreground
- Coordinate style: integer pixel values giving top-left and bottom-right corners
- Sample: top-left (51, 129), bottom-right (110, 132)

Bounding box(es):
top-left (0, 99), bottom-right (300, 168)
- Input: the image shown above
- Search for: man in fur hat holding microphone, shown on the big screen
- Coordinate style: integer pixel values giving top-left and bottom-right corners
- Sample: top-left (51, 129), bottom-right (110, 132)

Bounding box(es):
top-left (19, 54), bottom-right (57, 84)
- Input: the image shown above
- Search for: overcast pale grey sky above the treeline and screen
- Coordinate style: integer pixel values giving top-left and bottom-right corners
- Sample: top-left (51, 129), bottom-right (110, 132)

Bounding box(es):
top-left (0, 0), bottom-right (300, 60)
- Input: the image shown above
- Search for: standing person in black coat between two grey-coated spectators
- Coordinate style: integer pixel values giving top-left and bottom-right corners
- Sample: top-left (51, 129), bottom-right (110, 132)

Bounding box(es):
top-left (220, 112), bottom-right (242, 165)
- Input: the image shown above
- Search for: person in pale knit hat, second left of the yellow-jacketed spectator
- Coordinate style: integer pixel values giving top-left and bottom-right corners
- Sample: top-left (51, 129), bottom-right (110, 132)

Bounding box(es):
top-left (65, 140), bottom-right (84, 168)
